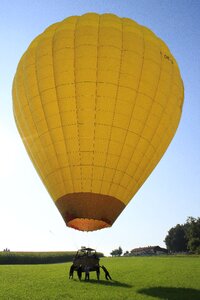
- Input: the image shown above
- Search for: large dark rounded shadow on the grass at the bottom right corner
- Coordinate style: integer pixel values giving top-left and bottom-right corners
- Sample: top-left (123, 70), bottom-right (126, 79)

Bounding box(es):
top-left (137, 286), bottom-right (200, 300)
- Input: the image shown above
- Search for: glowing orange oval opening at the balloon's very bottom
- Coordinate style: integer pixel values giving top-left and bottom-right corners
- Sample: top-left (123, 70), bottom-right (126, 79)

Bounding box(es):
top-left (67, 218), bottom-right (111, 231)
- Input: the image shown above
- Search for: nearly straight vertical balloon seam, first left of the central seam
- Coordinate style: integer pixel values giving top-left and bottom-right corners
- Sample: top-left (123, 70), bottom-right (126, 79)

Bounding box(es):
top-left (74, 17), bottom-right (83, 192)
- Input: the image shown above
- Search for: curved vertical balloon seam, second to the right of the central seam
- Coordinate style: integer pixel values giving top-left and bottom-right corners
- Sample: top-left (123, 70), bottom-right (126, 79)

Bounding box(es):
top-left (106, 22), bottom-right (145, 195)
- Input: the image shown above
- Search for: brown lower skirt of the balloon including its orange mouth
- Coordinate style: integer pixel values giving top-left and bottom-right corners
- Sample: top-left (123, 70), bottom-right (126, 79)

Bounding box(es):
top-left (55, 192), bottom-right (125, 231)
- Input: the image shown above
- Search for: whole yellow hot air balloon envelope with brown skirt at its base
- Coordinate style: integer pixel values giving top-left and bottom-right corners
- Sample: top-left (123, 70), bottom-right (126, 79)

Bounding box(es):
top-left (13, 13), bottom-right (184, 231)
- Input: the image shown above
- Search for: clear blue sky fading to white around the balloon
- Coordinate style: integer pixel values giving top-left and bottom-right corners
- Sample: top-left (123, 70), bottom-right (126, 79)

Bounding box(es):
top-left (0, 0), bottom-right (200, 254)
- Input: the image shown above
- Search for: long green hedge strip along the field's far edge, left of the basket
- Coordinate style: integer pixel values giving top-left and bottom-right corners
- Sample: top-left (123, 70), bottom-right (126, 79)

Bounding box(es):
top-left (0, 252), bottom-right (76, 265)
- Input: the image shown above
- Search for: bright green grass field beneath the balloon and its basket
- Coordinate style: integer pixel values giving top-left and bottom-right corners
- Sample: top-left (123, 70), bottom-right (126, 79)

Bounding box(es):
top-left (0, 256), bottom-right (200, 300)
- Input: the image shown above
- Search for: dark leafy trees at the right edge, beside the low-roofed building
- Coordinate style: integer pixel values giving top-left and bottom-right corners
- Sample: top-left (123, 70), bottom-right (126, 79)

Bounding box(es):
top-left (164, 217), bottom-right (200, 254)
